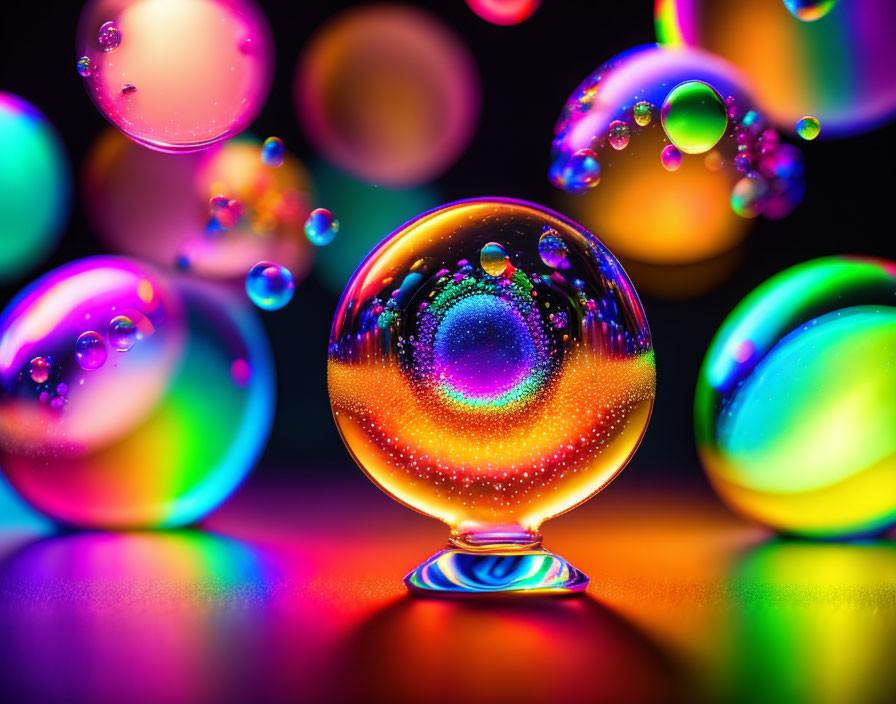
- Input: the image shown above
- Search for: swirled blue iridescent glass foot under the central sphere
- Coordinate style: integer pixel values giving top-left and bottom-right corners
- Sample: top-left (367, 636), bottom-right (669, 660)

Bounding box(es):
top-left (404, 545), bottom-right (589, 598)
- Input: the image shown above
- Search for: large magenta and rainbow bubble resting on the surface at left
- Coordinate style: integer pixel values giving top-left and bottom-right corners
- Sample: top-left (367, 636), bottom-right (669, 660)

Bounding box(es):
top-left (0, 257), bottom-right (274, 529)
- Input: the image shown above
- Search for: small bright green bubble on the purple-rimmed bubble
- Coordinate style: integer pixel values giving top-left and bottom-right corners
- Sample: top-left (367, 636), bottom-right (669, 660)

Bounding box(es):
top-left (660, 81), bottom-right (728, 154)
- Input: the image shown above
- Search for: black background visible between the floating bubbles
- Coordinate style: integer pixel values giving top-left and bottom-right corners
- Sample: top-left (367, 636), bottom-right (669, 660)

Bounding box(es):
top-left (0, 0), bottom-right (896, 490)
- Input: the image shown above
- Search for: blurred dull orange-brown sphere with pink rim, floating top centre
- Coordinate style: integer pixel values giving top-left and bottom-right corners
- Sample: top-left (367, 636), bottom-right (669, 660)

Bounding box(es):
top-left (294, 4), bottom-right (480, 187)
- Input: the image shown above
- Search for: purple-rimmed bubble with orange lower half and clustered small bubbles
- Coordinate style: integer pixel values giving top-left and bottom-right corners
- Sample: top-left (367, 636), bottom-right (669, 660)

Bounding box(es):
top-left (548, 45), bottom-right (805, 296)
